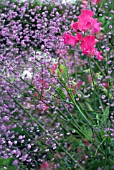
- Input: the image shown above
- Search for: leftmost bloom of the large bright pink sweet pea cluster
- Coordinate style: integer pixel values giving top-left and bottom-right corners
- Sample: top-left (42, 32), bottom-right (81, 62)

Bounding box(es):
top-left (63, 33), bottom-right (78, 46)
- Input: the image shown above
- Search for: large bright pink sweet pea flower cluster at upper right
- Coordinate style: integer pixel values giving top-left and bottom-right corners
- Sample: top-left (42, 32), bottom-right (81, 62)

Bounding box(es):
top-left (63, 10), bottom-right (103, 60)
